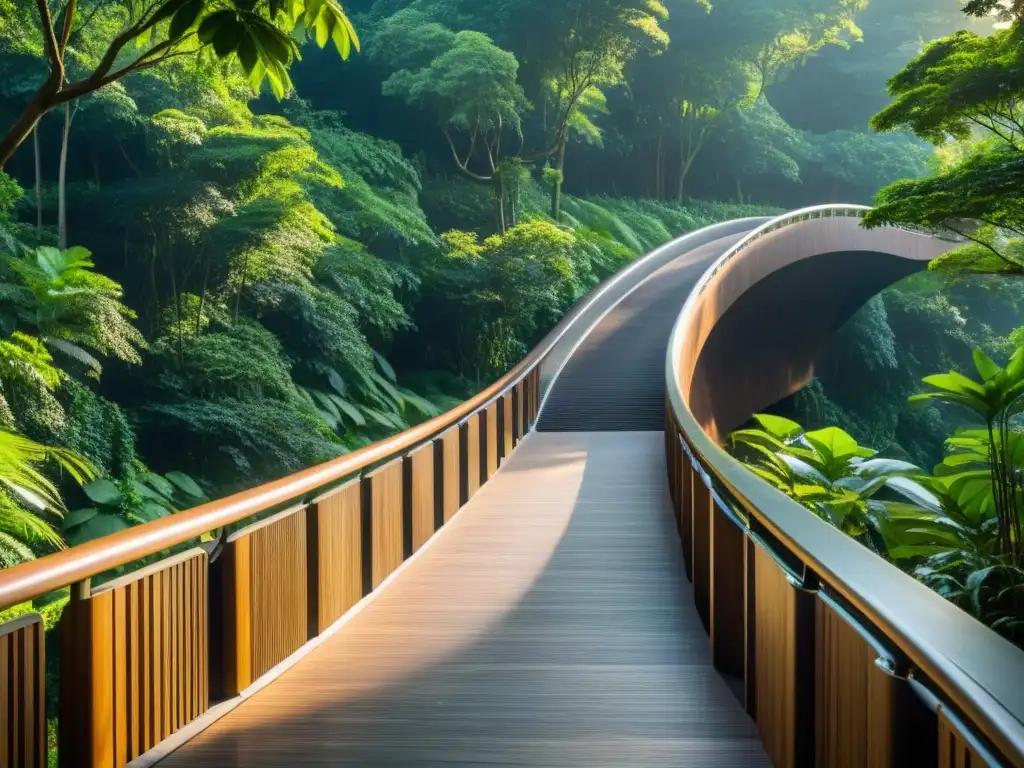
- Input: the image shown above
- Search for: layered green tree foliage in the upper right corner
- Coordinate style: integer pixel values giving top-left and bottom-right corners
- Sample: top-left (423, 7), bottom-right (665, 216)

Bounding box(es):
top-left (865, 17), bottom-right (1024, 274)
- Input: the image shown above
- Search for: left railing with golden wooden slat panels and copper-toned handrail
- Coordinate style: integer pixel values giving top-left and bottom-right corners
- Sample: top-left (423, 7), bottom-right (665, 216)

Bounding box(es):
top-left (0, 219), bottom-right (761, 768)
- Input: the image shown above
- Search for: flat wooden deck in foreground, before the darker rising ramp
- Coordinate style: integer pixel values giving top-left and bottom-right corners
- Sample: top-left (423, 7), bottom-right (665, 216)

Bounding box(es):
top-left (162, 432), bottom-right (768, 768)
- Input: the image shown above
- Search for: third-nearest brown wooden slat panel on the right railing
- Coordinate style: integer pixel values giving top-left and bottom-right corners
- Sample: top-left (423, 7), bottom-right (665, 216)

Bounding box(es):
top-left (749, 547), bottom-right (814, 768)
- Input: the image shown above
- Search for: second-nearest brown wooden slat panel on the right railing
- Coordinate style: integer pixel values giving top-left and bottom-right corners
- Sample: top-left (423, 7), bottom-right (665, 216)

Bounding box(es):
top-left (814, 596), bottom-right (902, 768)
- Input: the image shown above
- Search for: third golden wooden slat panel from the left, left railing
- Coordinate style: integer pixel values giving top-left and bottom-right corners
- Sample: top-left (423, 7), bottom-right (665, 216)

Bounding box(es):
top-left (228, 509), bottom-right (309, 696)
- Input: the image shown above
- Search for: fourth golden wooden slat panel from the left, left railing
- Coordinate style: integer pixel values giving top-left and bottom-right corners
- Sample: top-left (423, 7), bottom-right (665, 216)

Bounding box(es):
top-left (309, 480), bottom-right (362, 634)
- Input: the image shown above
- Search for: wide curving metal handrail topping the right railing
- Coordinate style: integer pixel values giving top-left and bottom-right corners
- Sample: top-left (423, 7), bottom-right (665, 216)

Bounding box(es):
top-left (666, 206), bottom-right (1024, 765)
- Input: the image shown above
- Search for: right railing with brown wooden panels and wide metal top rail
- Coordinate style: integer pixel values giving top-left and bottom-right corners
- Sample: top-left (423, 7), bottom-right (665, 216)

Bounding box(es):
top-left (666, 206), bottom-right (1024, 767)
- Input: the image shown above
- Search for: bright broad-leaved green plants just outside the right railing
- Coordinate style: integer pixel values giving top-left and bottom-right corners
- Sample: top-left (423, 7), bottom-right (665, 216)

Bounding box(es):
top-left (730, 335), bottom-right (1024, 644)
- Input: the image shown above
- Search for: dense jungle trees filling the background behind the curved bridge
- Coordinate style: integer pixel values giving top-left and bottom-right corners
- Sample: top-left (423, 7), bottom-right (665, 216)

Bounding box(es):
top-left (0, 0), bottom-right (1024, 651)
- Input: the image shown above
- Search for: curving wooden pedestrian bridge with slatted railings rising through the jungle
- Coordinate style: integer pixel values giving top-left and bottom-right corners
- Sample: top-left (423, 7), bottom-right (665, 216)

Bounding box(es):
top-left (0, 207), bottom-right (1024, 768)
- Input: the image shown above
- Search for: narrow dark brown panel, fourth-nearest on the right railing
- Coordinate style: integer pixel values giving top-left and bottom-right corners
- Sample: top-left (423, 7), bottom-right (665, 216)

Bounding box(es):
top-left (710, 501), bottom-right (746, 676)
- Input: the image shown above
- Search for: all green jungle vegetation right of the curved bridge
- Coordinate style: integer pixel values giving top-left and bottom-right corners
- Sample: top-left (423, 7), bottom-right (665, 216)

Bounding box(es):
top-left (731, 0), bottom-right (1024, 647)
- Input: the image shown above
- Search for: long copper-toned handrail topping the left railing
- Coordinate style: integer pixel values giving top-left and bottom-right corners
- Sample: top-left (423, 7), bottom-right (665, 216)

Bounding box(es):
top-left (0, 219), bottom-right (763, 609)
